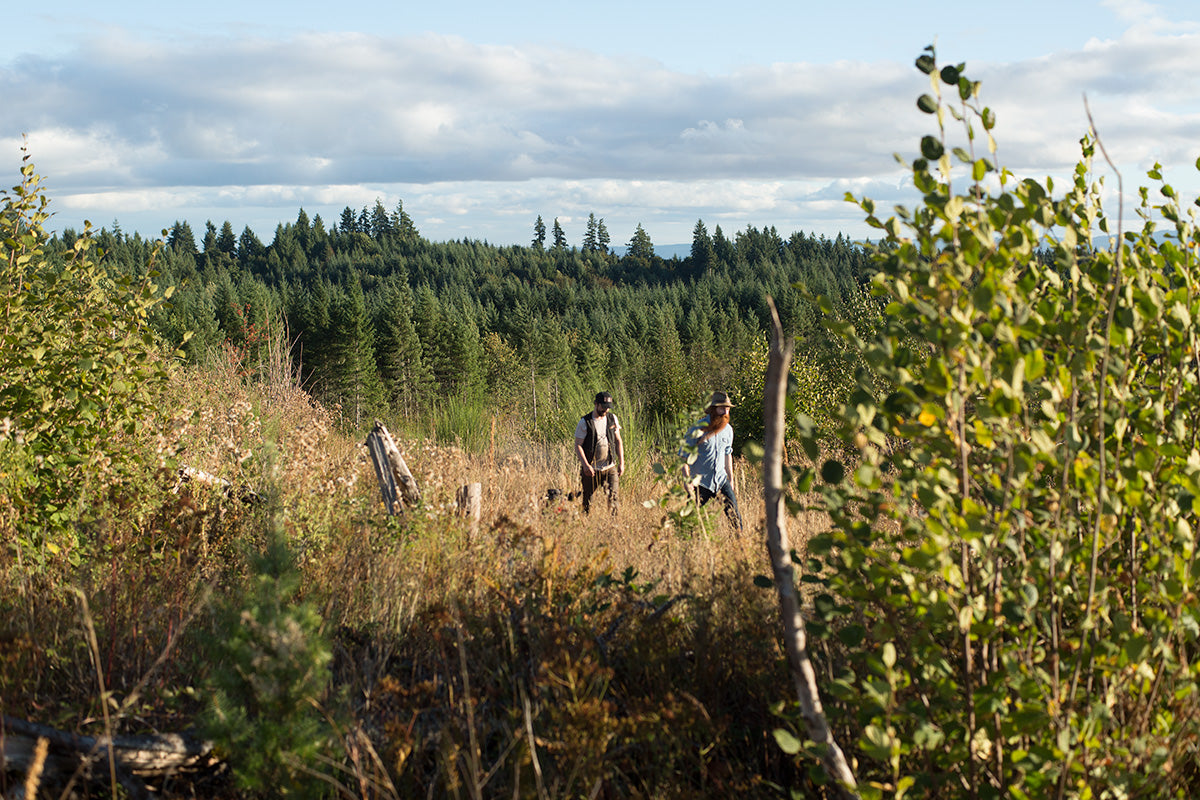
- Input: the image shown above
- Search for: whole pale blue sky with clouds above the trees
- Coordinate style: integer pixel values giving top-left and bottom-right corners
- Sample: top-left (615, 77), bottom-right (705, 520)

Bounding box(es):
top-left (7, 0), bottom-right (1200, 246)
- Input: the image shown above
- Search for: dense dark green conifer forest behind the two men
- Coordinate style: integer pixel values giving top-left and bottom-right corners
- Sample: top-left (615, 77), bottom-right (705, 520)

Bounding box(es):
top-left (49, 201), bottom-right (872, 448)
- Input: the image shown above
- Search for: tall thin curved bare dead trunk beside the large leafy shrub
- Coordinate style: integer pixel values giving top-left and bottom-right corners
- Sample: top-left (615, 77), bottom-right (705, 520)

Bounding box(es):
top-left (762, 297), bottom-right (858, 798)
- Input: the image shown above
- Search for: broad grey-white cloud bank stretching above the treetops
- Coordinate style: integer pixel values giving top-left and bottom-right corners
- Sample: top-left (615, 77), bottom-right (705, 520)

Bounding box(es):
top-left (7, 17), bottom-right (1200, 242)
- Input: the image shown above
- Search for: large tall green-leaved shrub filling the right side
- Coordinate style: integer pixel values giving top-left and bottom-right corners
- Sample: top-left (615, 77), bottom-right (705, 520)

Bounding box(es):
top-left (798, 48), bottom-right (1200, 798)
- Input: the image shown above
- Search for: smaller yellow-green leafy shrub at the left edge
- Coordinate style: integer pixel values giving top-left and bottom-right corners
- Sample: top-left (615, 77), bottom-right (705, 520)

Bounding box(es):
top-left (0, 156), bottom-right (177, 564)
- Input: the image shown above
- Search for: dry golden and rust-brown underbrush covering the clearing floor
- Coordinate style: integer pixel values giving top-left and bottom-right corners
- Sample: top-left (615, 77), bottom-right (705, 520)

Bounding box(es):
top-left (0, 363), bottom-right (830, 798)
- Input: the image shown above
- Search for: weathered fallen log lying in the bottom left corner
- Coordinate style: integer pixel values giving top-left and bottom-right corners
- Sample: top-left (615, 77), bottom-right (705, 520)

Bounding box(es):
top-left (0, 715), bottom-right (221, 798)
